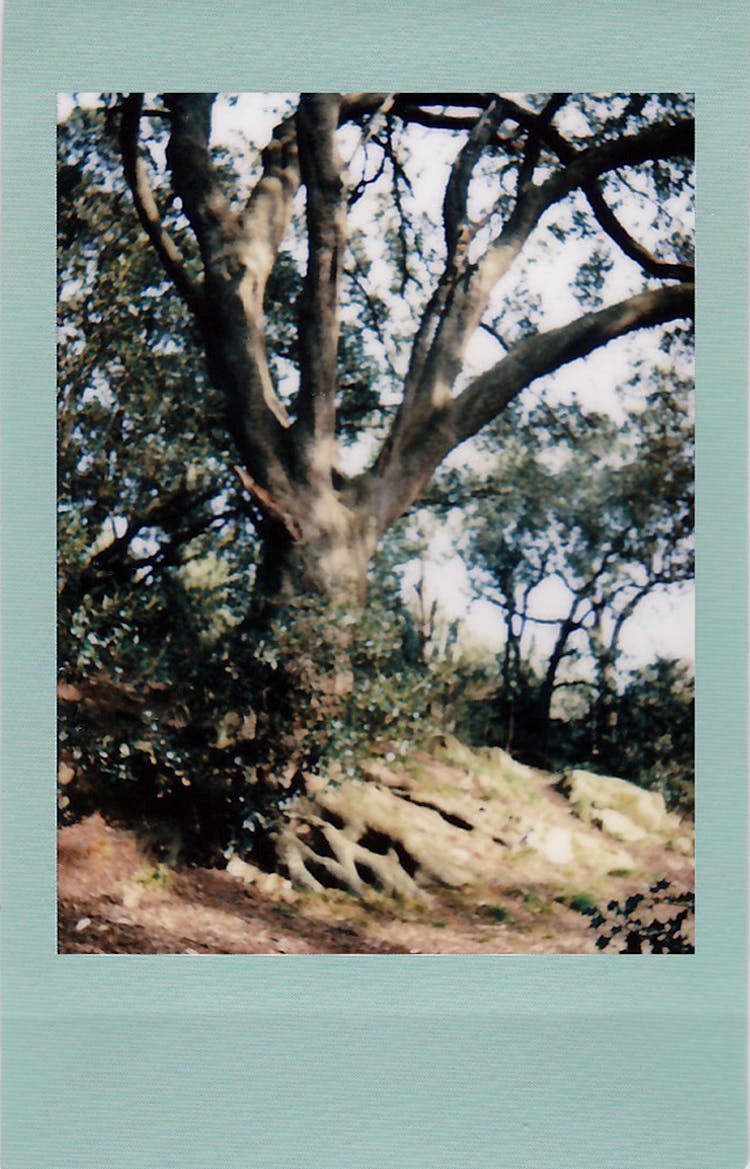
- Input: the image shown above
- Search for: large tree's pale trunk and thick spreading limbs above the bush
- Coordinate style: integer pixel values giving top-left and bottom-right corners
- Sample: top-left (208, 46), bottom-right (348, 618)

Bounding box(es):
top-left (102, 94), bottom-right (694, 602)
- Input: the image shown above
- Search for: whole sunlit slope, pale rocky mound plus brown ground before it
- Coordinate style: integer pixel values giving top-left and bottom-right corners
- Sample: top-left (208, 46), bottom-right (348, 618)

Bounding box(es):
top-left (58, 740), bottom-right (693, 954)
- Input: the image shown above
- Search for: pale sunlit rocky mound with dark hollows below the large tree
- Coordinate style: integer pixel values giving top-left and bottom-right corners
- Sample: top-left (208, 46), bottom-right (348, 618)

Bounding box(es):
top-left (245, 740), bottom-right (693, 900)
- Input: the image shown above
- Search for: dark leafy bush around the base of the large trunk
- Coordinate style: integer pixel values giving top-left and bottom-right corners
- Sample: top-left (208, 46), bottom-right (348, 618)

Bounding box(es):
top-left (60, 579), bottom-right (476, 859)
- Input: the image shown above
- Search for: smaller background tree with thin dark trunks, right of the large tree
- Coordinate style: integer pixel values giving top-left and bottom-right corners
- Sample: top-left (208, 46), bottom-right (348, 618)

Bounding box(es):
top-left (457, 338), bottom-right (694, 765)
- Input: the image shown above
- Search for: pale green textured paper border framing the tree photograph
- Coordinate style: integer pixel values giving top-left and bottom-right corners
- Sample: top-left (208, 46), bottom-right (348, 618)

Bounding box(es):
top-left (1, 0), bottom-right (750, 1169)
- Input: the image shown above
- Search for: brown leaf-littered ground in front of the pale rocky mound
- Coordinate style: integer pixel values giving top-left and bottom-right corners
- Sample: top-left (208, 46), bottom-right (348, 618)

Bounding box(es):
top-left (58, 743), bottom-right (693, 954)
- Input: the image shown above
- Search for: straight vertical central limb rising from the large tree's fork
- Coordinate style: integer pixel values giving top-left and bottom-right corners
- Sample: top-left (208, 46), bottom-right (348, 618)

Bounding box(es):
top-left (296, 94), bottom-right (346, 476)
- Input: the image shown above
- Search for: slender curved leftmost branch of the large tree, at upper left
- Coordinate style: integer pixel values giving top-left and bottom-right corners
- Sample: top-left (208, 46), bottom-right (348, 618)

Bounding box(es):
top-left (120, 94), bottom-right (204, 319)
